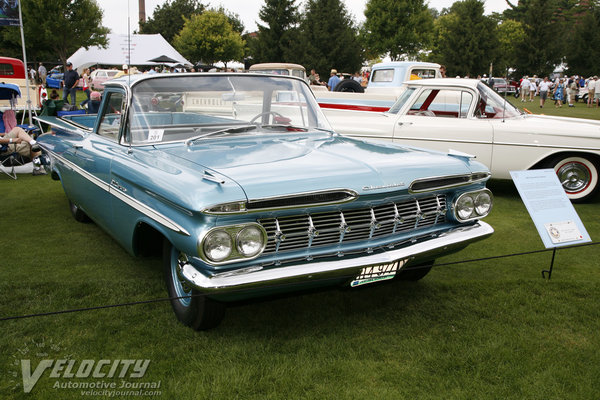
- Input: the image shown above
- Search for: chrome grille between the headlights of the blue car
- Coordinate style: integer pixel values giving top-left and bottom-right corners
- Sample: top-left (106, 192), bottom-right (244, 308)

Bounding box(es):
top-left (258, 195), bottom-right (446, 254)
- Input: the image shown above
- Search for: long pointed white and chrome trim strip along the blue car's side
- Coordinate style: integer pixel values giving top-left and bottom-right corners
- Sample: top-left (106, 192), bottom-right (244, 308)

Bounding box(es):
top-left (46, 150), bottom-right (190, 236)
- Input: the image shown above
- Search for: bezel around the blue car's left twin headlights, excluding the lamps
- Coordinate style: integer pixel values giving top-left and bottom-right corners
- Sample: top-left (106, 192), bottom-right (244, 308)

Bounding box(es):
top-left (198, 222), bottom-right (267, 265)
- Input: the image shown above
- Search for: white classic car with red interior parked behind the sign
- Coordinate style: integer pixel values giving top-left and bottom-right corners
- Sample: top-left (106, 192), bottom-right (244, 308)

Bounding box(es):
top-left (323, 79), bottom-right (600, 201)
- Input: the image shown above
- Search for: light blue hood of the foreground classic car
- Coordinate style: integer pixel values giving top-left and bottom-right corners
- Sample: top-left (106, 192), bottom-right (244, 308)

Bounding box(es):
top-left (161, 134), bottom-right (485, 200)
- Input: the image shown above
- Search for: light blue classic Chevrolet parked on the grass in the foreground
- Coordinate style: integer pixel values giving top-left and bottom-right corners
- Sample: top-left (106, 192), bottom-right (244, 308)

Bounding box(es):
top-left (39, 74), bottom-right (493, 329)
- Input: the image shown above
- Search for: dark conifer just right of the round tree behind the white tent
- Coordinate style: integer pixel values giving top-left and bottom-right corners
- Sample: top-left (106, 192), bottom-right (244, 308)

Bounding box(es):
top-left (251, 0), bottom-right (299, 62)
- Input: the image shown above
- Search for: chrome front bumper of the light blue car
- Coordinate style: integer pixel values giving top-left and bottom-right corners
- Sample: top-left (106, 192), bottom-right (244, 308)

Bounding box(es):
top-left (179, 221), bottom-right (494, 294)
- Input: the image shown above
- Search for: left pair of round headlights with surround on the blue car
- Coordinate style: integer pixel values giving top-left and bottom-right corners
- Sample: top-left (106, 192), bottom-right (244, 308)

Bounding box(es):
top-left (198, 223), bottom-right (267, 265)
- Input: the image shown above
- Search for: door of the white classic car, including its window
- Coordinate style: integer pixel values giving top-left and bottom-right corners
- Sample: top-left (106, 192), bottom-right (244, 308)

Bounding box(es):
top-left (393, 86), bottom-right (494, 167)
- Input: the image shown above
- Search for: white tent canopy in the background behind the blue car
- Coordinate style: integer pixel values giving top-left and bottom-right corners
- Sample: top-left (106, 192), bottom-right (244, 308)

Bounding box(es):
top-left (67, 33), bottom-right (192, 70)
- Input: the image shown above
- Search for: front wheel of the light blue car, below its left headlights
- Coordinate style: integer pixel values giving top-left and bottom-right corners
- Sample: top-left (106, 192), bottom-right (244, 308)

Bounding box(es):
top-left (163, 240), bottom-right (226, 331)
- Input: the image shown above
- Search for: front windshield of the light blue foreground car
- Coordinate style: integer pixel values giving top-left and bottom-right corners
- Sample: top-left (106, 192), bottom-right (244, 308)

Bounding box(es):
top-left (127, 74), bottom-right (331, 144)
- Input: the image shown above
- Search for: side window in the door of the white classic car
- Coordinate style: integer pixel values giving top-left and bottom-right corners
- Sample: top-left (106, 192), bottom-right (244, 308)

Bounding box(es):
top-left (408, 89), bottom-right (473, 118)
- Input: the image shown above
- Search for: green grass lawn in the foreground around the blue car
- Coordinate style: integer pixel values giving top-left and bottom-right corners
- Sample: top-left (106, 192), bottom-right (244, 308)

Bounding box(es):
top-left (0, 175), bottom-right (600, 400)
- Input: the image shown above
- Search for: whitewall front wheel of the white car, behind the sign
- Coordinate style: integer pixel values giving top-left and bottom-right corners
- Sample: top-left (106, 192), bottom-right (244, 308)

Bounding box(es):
top-left (545, 155), bottom-right (598, 203)
